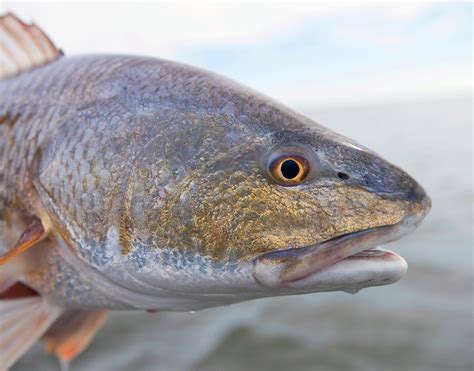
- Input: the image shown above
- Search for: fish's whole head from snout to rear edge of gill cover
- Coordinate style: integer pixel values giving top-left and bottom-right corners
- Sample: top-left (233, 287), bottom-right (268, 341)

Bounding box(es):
top-left (35, 60), bottom-right (431, 310)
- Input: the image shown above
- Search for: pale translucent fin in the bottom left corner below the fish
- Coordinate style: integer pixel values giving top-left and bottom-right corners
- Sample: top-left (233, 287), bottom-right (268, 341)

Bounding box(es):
top-left (0, 296), bottom-right (63, 370)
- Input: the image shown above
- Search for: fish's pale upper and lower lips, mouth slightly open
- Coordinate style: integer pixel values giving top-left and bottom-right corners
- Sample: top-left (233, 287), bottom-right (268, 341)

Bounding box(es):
top-left (253, 215), bottom-right (419, 291)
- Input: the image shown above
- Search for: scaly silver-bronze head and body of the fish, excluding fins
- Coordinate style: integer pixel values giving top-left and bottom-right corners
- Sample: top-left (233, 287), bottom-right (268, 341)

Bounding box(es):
top-left (0, 13), bottom-right (430, 368)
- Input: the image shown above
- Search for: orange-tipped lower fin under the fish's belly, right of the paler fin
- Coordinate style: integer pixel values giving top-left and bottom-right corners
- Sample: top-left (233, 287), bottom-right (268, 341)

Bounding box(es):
top-left (42, 310), bottom-right (107, 362)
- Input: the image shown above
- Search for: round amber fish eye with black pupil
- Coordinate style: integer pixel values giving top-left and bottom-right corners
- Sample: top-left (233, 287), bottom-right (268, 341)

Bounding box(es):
top-left (268, 155), bottom-right (310, 186)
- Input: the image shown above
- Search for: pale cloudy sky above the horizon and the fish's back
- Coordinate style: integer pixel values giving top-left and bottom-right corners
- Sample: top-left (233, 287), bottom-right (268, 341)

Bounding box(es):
top-left (0, 0), bottom-right (472, 107)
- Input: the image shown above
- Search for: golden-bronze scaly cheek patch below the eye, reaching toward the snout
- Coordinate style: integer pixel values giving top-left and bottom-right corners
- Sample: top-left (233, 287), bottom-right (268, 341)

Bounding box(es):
top-left (147, 169), bottom-right (404, 262)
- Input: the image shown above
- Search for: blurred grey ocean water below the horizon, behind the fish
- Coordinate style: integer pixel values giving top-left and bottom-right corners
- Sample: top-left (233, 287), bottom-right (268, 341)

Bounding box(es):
top-left (13, 96), bottom-right (474, 371)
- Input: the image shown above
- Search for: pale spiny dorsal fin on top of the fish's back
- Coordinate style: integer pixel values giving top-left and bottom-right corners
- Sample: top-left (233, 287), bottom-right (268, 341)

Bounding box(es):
top-left (0, 13), bottom-right (62, 79)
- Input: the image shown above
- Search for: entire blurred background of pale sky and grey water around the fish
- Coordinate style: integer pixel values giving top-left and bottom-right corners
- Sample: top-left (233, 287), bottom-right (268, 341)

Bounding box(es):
top-left (0, 1), bottom-right (474, 371)
